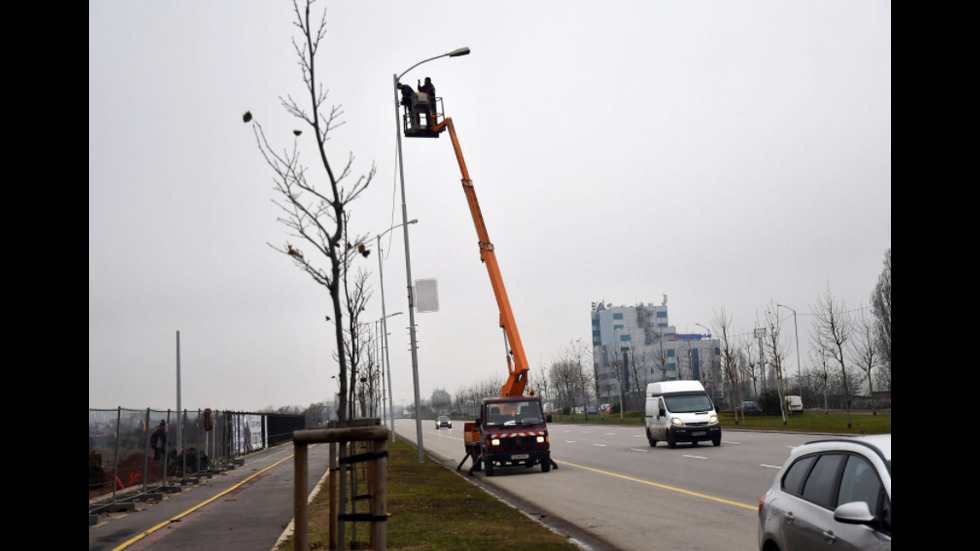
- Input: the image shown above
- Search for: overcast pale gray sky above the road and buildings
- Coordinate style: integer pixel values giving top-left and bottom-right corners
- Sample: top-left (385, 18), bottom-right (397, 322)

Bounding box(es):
top-left (89, 0), bottom-right (891, 411)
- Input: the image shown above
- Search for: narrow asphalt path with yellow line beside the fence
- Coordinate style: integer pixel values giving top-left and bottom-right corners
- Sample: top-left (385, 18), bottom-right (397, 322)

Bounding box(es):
top-left (88, 442), bottom-right (328, 551)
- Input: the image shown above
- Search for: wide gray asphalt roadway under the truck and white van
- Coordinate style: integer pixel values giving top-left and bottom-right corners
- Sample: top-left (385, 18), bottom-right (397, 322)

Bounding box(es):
top-left (396, 420), bottom-right (814, 551)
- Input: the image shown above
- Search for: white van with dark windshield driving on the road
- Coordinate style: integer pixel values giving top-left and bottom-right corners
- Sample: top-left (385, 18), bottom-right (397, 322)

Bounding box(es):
top-left (646, 381), bottom-right (721, 448)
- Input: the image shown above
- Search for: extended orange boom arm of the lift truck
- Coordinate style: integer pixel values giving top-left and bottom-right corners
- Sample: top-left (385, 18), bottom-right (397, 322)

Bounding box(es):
top-left (432, 117), bottom-right (528, 396)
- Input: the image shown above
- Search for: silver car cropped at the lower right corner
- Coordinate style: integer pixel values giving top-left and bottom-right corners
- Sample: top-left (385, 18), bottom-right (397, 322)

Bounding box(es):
top-left (759, 434), bottom-right (892, 551)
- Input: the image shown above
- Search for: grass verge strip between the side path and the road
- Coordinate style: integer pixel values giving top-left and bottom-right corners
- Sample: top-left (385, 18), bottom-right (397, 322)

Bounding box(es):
top-left (280, 439), bottom-right (581, 551)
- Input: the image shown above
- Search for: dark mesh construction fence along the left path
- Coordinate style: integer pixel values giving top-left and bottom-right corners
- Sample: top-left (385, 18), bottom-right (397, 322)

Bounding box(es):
top-left (88, 407), bottom-right (306, 512)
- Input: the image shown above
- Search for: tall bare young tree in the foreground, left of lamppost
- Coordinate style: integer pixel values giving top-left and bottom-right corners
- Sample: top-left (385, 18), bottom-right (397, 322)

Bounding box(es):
top-left (243, 0), bottom-right (375, 422)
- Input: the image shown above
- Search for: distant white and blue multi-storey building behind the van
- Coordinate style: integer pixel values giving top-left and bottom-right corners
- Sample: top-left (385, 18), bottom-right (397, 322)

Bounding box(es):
top-left (592, 296), bottom-right (722, 410)
